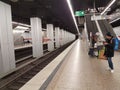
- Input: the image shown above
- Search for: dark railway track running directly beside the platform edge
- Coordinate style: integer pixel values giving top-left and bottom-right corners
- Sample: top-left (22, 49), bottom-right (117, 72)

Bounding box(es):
top-left (0, 42), bottom-right (72, 90)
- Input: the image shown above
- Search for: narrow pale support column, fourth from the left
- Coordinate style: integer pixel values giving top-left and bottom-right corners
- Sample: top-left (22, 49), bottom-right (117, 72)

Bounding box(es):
top-left (55, 27), bottom-right (60, 48)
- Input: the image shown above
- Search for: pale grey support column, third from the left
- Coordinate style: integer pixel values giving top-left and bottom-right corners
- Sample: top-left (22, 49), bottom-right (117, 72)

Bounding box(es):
top-left (47, 24), bottom-right (54, 51)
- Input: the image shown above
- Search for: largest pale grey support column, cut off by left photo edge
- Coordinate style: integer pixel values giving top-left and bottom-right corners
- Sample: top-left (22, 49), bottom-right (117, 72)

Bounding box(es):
top-left (0, 1), bottom-right (16, 78)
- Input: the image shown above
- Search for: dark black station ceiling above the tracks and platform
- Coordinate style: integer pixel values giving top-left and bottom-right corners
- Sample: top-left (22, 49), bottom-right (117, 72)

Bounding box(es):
top-left (1, 0), bottom-right (110, 34)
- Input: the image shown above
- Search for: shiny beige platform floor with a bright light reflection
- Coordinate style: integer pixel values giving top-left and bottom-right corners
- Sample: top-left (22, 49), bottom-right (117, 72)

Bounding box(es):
top-left (46, 40), bottom-right (120, 90)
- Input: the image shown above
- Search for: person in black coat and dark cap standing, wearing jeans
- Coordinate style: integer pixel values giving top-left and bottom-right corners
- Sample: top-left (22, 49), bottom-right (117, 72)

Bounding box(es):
top-left (103, 32), bottom-right (115, 73)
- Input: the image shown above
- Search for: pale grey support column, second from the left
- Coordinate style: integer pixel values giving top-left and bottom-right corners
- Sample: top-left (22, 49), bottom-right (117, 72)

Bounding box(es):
top-left (30, 17), bottom-right (43, 58)
